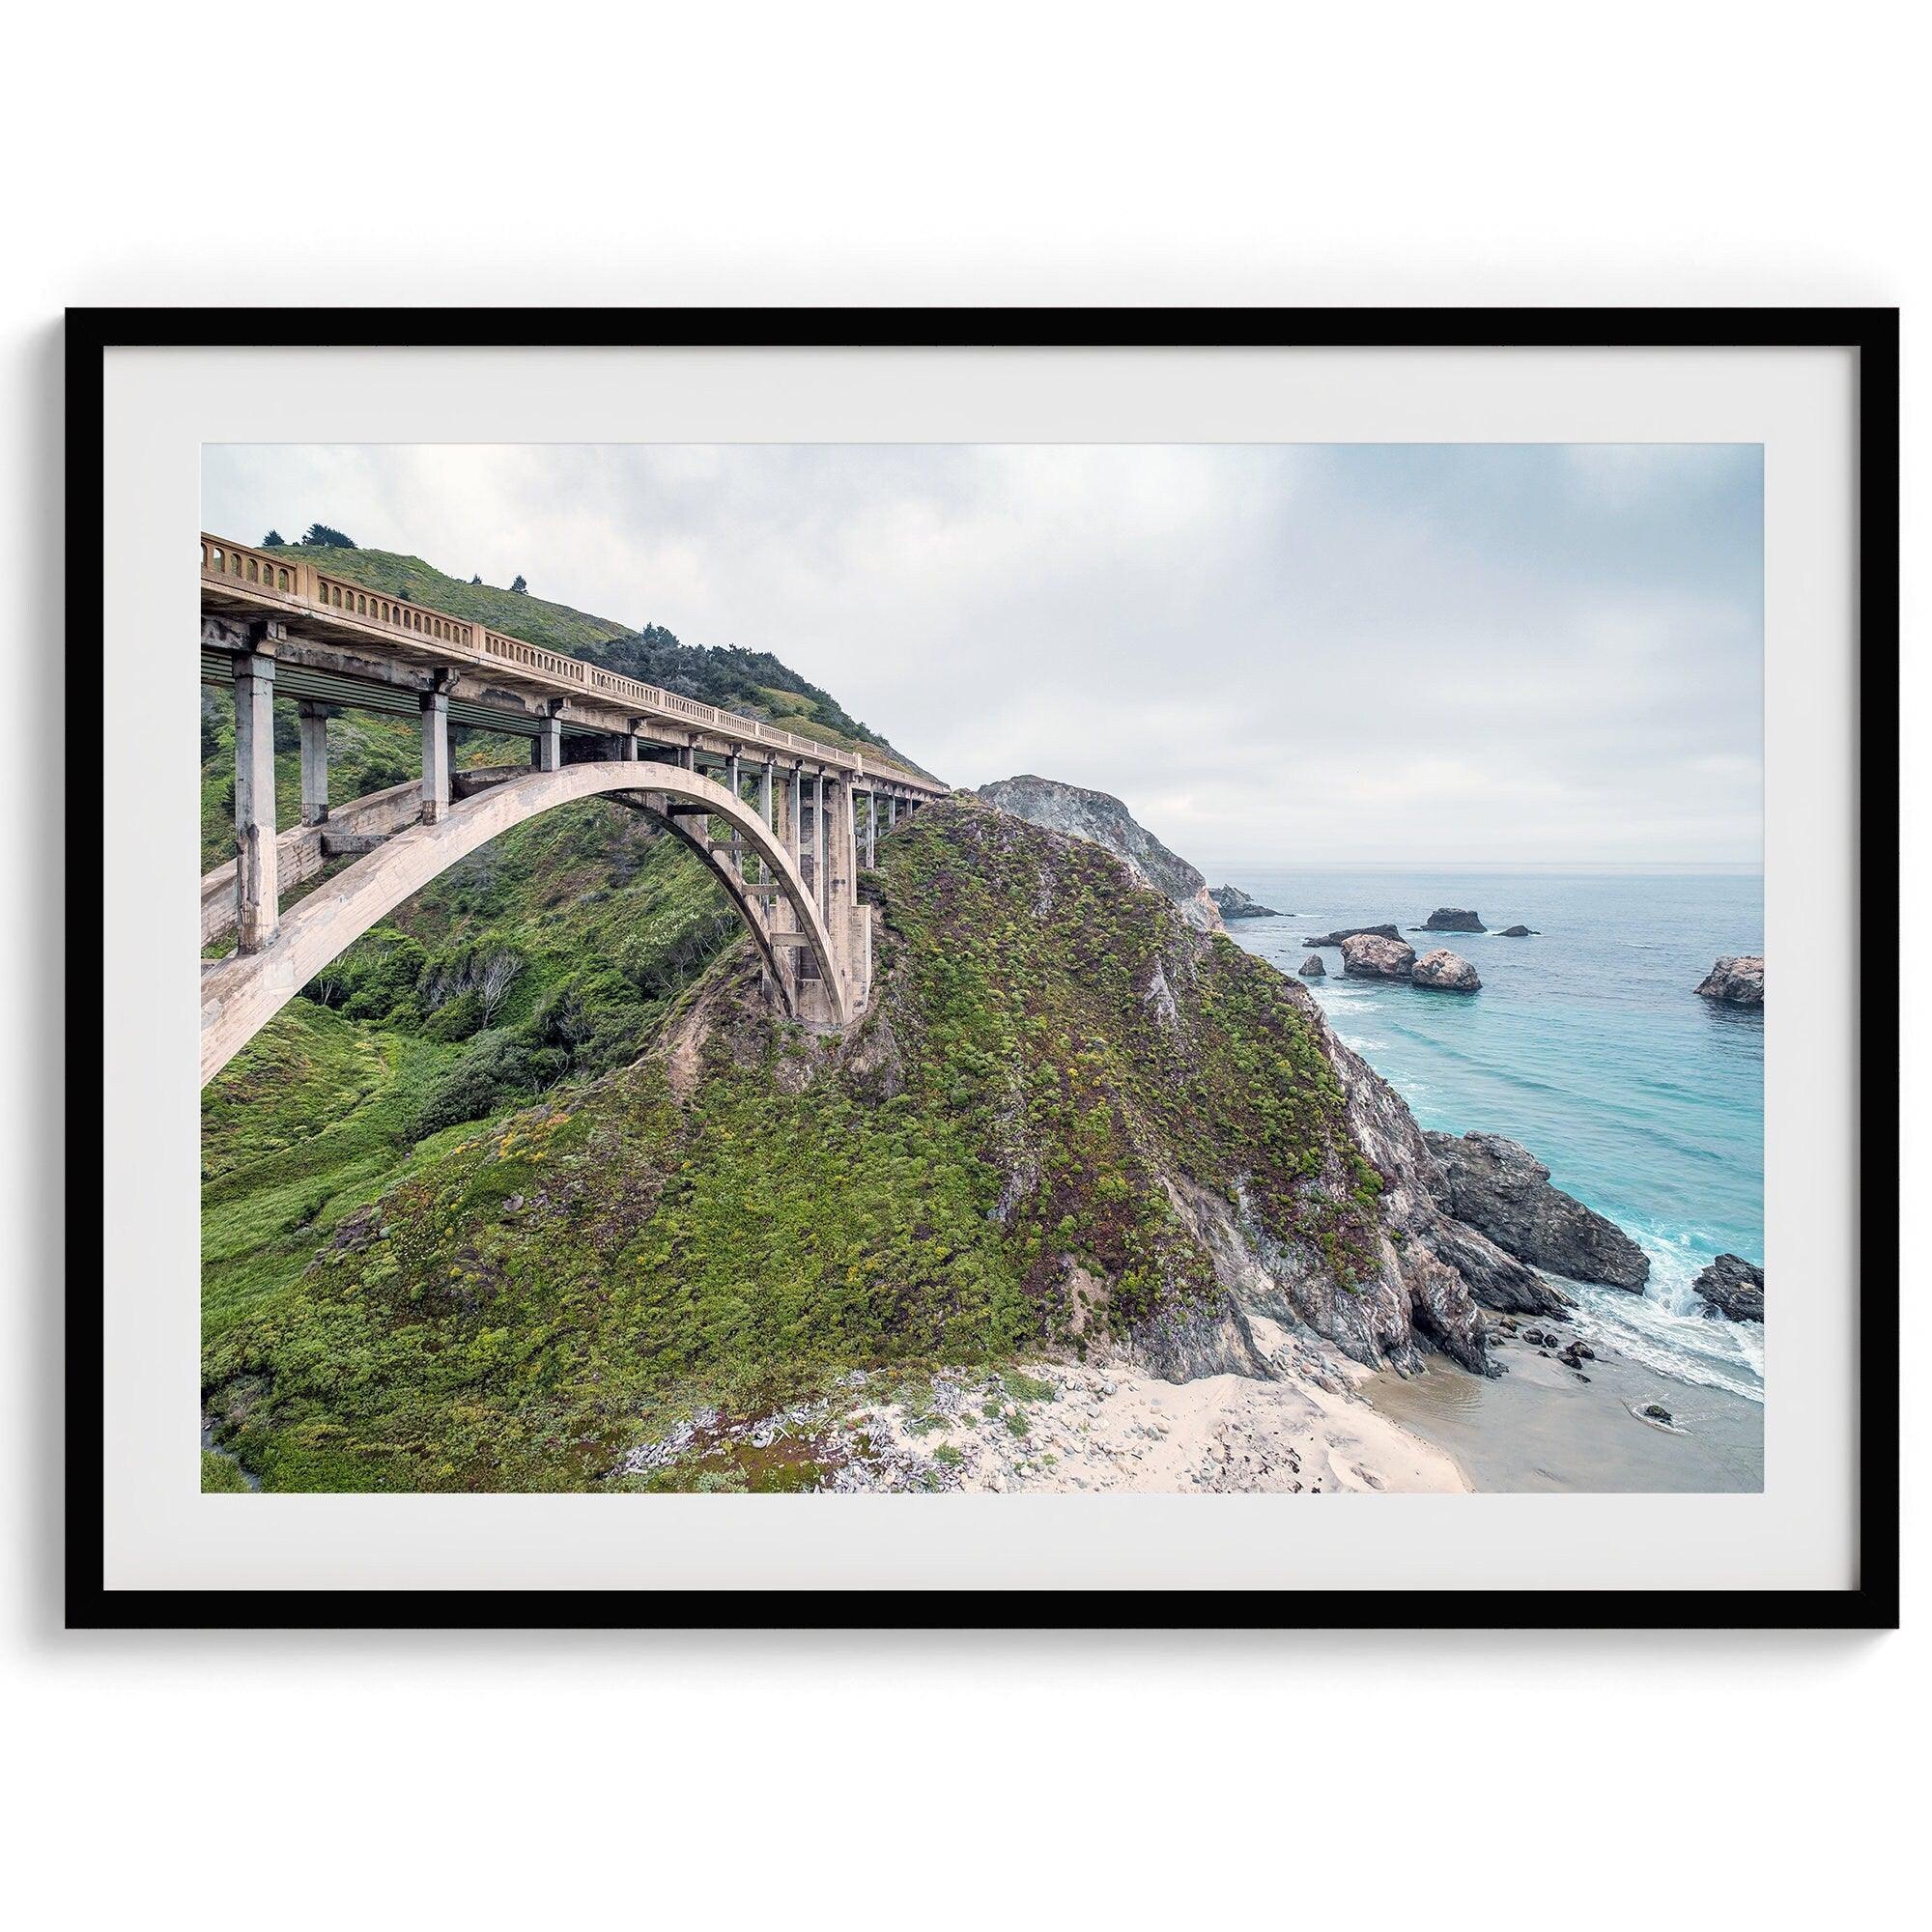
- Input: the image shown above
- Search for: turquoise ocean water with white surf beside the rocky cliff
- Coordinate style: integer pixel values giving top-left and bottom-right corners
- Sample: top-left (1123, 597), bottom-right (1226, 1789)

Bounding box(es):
top-left (1209, 866), bottom-right (1764, 1403)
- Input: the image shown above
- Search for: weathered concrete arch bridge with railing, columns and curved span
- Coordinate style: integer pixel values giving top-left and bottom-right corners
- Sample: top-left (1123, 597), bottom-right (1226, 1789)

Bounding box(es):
top-left (201, 535), bottom-right (945, 1084)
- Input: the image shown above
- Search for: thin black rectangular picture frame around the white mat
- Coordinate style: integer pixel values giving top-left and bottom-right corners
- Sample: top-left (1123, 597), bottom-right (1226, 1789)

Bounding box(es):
top-left (66, 307), bottom-right (1899, 1631)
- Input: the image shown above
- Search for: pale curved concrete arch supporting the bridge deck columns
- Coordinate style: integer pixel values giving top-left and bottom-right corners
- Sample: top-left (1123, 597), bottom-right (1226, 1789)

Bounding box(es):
top-left (201, 759), bottom-right (856, 1086)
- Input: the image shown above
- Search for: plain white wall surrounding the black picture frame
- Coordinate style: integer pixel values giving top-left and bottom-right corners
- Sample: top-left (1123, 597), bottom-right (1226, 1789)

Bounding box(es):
top-left (0, 0), bottom-right (1932, 1928)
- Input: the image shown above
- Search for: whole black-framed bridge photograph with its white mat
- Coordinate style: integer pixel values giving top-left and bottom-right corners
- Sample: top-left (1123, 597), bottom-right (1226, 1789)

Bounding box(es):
top-left (68, 309), bottom-right (1899, 1629)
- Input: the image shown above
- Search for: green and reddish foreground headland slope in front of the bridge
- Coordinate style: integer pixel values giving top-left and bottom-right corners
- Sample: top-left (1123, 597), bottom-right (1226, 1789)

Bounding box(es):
top-left (205, 804), bottom-right (1378, 1490)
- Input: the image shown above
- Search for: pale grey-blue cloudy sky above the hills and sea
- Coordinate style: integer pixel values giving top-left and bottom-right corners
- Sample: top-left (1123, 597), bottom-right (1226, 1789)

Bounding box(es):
top-left (203, 444), bottom-right (1764, 867)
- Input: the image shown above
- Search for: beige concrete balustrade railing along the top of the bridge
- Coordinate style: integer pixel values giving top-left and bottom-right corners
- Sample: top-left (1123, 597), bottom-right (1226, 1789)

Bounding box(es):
top-left (201, 531), bottom-right (933, 788)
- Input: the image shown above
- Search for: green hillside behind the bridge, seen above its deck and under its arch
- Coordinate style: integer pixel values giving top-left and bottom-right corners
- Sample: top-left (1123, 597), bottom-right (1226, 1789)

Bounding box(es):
top-left (201, 549), bottom-right (943, 1391)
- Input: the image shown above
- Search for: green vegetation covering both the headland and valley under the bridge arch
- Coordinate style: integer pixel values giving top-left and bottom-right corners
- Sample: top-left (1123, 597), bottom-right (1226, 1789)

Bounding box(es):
top-left (203, 800), bottom-right (1381, 1490)
